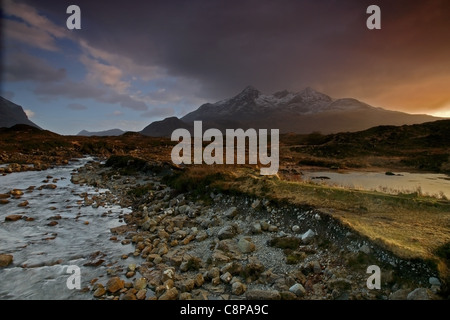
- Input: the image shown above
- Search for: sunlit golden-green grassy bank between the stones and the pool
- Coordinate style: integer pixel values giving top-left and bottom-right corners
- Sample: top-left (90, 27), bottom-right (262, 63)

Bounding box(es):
top-left (163, 166), bottom-right (450, 278)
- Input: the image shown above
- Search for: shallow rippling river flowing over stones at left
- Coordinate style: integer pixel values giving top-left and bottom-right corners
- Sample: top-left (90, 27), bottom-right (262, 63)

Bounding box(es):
top-left (0, 158), bottom-right (134, 300)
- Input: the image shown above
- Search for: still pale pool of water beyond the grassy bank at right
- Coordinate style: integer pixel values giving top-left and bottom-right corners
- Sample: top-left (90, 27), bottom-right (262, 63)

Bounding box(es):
top-left (303, 171), bottom-right (450, 198)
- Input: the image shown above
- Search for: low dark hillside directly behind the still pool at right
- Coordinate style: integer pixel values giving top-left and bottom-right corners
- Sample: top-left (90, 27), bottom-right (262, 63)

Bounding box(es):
top-left (288, 119), bottom-right (450, 173)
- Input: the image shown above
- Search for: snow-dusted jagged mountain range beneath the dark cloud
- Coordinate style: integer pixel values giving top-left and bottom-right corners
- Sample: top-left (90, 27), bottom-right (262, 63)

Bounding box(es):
top-left (143, 86), bottom-right (441, 136)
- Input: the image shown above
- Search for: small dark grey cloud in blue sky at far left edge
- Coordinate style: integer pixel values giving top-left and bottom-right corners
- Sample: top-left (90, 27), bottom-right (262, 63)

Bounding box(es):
top-left (4, 52), bottom-right (67, 82)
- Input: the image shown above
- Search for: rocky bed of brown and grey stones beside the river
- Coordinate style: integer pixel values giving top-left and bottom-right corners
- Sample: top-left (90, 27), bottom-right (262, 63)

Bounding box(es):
top-left (65, 162), bottom-right (441, 300)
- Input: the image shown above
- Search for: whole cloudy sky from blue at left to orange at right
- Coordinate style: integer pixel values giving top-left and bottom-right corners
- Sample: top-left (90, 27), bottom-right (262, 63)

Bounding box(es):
top-left (0, 0), bottom-right (450, 135)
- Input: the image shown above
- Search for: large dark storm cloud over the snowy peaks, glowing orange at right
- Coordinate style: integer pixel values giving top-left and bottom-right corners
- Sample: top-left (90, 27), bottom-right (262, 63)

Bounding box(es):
top-left (16, 0), bottom-right (450, 108)
